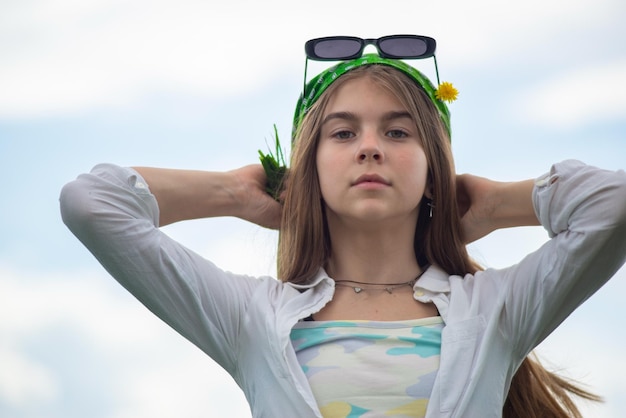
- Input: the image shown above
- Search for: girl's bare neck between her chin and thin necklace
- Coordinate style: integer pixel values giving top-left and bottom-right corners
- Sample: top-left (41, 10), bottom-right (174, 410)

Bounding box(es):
top-left (326, 216), bottom-right (421, 284)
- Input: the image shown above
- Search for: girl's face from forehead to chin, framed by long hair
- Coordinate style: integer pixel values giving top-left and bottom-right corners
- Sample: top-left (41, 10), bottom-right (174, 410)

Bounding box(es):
top-left (317, 76), bottom-right (428, 226)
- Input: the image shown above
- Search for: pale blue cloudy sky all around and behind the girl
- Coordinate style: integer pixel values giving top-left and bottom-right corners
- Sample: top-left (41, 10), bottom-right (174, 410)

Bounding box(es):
top-left (0, 0), bottom-right (626, 418)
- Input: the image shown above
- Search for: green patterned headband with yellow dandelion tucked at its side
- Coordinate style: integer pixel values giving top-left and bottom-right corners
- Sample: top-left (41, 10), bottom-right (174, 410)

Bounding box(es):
top-left (292, 54), bottom-right (456, 140)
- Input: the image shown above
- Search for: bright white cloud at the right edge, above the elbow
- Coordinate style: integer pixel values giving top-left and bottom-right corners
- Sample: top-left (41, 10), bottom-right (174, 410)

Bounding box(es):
top-left (513, 60), bottom-right (626, 129)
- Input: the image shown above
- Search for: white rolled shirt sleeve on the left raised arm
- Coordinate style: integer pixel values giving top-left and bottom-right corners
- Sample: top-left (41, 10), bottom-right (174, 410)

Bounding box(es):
top-left (60, 164), bottom-right (258, 372)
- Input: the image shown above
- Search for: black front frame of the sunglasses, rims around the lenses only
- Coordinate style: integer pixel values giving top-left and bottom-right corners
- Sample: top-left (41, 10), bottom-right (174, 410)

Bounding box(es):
top-left (304, 35), bottom-right (437, 61)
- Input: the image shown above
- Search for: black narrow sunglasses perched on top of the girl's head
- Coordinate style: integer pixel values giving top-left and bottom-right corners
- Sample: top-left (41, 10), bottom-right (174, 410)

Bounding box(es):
top-left (302, 35), bottom-right (439, 97)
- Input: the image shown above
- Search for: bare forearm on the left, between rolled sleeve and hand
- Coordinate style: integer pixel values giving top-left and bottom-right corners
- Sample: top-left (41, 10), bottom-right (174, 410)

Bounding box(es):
top-left (134, 167), bottom-right (240, 226)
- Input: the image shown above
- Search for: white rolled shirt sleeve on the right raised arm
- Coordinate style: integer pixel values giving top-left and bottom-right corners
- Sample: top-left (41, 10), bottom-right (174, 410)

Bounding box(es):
top-left (502, 160), bottom-right (626, 353)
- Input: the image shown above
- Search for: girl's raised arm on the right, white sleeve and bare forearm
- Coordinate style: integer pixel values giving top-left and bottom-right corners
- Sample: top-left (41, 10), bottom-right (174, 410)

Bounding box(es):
top-left (464, 160), bottom-right (626, 357)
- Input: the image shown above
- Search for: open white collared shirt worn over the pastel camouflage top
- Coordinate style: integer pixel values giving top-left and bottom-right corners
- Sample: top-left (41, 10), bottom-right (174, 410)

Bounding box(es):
top-left (61, 161), bottom-right (626, 418)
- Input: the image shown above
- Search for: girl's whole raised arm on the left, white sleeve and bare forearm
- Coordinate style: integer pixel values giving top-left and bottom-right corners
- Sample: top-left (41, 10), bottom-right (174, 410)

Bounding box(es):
top-left (60, 164), bottom-right (280, 371)
